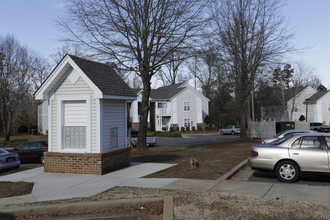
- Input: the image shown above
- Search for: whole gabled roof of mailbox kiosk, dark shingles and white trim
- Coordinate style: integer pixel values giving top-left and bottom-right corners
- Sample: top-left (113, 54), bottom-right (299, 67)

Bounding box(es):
top-left (35, 55), bottom-right (136, 99)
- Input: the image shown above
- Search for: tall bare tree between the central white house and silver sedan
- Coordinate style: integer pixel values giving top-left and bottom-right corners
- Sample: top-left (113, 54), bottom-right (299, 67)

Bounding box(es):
top-left (212, 0), bottom-right (291, 137)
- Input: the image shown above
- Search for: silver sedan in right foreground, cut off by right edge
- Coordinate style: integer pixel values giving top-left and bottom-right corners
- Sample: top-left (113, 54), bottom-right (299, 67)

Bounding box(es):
top-left (248, 133), bottom-right (330, 183)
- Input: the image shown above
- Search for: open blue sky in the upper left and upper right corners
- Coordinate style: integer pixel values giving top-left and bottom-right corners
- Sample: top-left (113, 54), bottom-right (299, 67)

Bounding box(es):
top-left (0, 0), bottom-right (330, 89)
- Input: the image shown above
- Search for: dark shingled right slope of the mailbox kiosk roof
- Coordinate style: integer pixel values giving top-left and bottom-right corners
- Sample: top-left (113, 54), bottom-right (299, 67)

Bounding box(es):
top-left (68, 55), bottom-right (136, 97)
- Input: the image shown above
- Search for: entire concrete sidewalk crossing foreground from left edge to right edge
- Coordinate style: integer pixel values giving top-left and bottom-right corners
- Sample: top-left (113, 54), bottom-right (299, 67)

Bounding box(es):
top-left (0, 161), bottom-right (330, 207)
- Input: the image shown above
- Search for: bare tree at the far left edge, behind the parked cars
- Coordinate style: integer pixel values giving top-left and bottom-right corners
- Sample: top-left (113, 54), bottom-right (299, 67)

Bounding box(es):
top-left (0, 35), bottom-right (31, 141)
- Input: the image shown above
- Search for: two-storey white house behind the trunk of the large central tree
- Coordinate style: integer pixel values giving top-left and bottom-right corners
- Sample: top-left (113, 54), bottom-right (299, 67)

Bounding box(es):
top-left (130, 82), bottom-right (209, 131)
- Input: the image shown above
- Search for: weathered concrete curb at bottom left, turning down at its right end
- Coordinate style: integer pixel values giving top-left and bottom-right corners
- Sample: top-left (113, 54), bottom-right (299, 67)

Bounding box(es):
top-left (0, 197), bottom-right (168, 217)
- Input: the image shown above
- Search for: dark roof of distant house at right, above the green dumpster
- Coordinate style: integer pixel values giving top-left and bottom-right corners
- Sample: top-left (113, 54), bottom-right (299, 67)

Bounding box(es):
top-left (262, 86), bottom-right (307, 106)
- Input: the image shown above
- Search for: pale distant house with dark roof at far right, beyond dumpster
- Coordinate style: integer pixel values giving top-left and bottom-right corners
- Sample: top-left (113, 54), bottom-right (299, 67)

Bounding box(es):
top-left (261, 86), bottom-right (330, 124)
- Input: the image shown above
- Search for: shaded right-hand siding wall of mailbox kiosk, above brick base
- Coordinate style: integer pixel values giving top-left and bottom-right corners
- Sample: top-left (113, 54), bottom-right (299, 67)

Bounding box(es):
top-left (101, 100), bottom-right (126, 152)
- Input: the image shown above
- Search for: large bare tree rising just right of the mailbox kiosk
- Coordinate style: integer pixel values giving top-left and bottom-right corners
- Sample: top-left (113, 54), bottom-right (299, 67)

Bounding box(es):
top-left (59, 0), bottom-right (204, 150)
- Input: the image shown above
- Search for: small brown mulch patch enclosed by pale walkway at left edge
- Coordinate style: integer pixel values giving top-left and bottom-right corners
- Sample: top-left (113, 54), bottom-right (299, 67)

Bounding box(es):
top-left (0, 182), bottom-right (34, 198)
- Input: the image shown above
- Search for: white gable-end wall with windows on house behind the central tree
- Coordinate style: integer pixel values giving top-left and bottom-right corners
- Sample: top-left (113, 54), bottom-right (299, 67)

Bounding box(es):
top-left (177, 89), bottom-right (197, 127)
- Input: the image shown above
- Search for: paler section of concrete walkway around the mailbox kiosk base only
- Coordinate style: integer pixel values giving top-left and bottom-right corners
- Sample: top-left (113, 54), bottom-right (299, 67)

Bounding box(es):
top-left (0, 163), bottom-right (177, 206)
